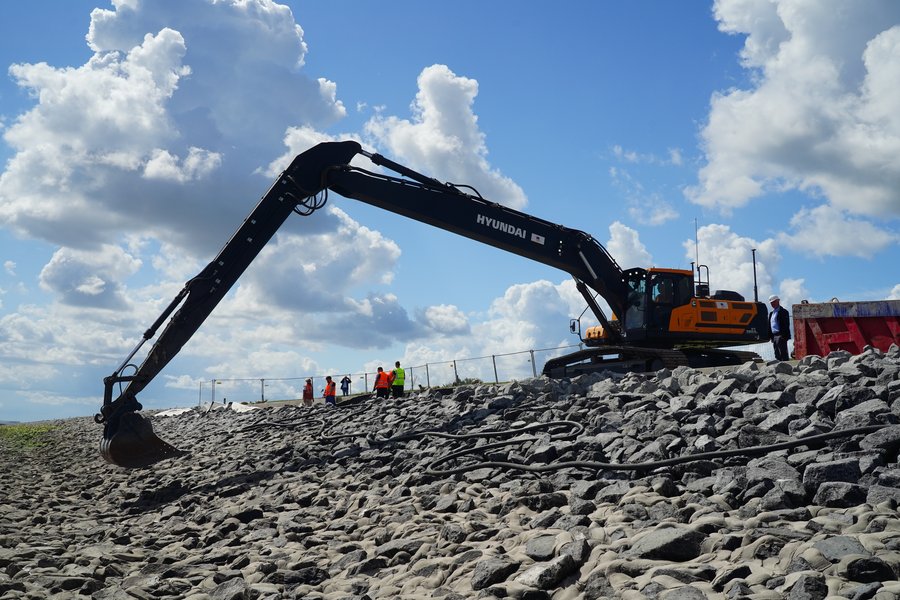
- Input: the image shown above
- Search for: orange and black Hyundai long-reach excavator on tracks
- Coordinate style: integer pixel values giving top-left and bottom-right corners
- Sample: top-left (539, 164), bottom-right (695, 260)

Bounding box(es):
top-left (94, 140), bottom-right (769, 468)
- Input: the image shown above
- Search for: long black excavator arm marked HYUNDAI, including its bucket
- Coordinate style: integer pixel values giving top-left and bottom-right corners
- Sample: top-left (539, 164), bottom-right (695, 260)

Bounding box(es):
top-left (95, 141), bottom-right (626, 467)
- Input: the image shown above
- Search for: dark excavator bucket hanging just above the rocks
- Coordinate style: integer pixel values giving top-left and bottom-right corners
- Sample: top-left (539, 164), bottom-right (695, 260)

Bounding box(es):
top-left (100, 412), bottom-right (187, 469)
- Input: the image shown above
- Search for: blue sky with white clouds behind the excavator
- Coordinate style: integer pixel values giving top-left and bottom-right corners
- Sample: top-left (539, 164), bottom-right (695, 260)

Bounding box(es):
top-left (0, 0), bottom-right (900, 421)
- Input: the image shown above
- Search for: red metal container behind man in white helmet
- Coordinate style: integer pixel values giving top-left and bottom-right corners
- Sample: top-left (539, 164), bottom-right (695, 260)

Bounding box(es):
top-left (793, 300), bottom-right (900, 358)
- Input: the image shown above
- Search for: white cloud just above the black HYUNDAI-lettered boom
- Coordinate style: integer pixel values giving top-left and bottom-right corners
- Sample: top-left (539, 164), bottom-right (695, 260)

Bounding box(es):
top-left (365, 65), bottom-right (527, 209)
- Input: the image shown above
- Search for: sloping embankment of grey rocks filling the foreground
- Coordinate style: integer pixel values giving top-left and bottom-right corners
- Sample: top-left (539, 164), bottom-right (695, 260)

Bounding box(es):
top-left (0, 348), bottom-right (900, 600)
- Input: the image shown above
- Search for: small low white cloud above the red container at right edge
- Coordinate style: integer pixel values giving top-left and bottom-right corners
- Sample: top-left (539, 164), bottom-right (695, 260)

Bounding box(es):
top-left (779, 205), bottom-right (900, 258)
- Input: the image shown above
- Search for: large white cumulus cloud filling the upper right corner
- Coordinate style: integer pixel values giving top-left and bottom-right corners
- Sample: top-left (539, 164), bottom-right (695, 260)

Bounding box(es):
top-left (686, 0), bottom-right (900, 223)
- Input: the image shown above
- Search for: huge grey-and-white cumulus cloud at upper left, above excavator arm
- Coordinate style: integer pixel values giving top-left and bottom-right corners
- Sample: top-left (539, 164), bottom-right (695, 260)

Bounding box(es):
top-left (0, 0), bottom-right (346, 254)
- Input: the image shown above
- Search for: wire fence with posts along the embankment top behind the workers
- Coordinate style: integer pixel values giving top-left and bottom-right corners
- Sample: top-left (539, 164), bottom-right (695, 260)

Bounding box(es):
top-left (198, 344), bottom-right (775, 403)
